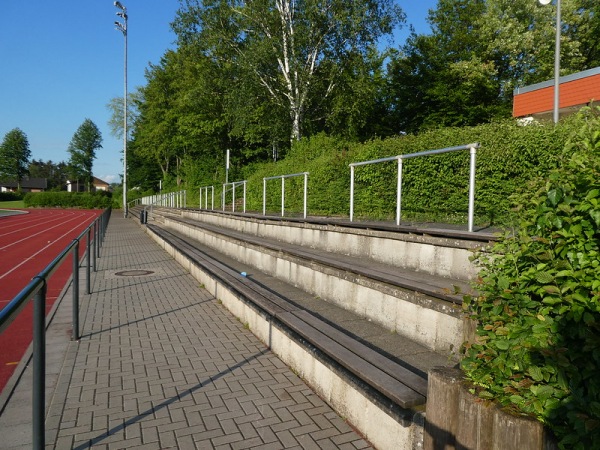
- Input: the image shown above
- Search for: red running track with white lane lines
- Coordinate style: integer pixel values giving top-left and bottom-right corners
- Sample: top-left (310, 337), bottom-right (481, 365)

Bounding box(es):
top-left (0, 209), bottom-right (102, 392)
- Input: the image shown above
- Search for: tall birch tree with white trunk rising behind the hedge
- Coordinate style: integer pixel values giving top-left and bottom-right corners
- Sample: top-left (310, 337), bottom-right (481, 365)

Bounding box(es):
top-left (173, 0), bottom-right (404, 140)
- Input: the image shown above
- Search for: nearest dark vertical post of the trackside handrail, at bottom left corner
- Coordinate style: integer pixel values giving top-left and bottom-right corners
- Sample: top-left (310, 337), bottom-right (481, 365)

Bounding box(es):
top-left (32, 279), bottom-right (46, 450)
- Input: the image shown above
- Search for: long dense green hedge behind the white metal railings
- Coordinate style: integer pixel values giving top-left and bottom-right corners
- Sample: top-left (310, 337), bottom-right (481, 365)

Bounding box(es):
top-left (236, 117), bottom-right (581, 225)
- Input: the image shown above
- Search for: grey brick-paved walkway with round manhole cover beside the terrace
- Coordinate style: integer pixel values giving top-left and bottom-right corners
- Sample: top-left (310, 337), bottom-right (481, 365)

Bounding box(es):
top-left (0, 213), bottom-right (369, 449)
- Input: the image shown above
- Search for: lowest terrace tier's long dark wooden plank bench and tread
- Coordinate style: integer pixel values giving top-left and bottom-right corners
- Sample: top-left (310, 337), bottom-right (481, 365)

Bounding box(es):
top-left (148, 225), bottom-right (438, 408)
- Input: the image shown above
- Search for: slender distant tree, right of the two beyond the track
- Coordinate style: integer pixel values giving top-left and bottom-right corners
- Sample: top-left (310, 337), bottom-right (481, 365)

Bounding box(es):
top-left (67, 119), bottom-right (102, 192)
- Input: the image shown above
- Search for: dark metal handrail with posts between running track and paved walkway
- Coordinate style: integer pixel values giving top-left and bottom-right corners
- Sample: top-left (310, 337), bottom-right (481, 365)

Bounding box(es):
top-left (0, 209), bottom-right (111, 450)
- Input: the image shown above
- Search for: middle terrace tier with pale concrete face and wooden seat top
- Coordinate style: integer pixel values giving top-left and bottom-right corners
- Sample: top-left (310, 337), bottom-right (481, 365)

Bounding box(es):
top-left (145, 206), bottom-right (488, 355)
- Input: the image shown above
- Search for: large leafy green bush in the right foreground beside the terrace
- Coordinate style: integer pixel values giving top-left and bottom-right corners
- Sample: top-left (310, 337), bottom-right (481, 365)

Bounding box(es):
top-left (462, 109), bottom-right (600, 449)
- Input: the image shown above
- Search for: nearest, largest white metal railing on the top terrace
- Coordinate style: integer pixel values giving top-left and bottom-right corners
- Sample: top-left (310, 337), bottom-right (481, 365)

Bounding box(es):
top-left (350, 142), bottom-right (479, 232)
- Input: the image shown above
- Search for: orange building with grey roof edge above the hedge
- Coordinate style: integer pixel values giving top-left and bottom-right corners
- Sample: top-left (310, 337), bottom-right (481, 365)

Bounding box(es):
top-left (513, 67), bottom-right (600, 120)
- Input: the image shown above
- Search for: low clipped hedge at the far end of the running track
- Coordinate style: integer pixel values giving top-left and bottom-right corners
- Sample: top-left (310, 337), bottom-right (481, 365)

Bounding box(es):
top-left (23, 191), bottom-right (112, 209)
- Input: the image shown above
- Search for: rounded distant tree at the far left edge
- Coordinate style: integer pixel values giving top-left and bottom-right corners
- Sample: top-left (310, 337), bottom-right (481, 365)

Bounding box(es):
top-left (0, 128), bottom-right (31, 190)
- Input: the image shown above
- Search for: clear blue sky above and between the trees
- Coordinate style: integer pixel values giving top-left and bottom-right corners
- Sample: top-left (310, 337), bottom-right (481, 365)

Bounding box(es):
top-left (0, 0), bottom-right (437, 183)
